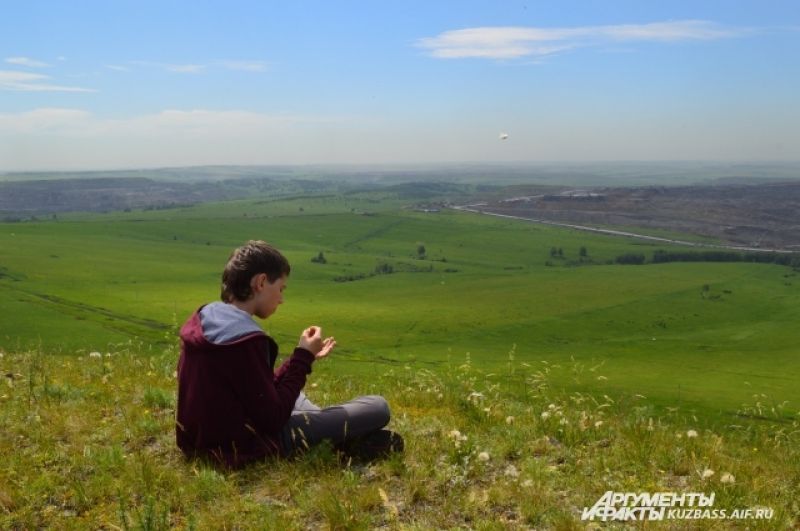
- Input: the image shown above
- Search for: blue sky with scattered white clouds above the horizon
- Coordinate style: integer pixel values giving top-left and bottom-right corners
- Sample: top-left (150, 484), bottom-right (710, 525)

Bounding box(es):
top-left (0, 0), bottom-right (800, 171)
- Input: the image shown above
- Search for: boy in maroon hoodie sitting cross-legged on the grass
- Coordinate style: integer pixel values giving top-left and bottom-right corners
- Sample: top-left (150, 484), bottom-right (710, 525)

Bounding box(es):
top-left (175, 241), bottom-right (403, 468)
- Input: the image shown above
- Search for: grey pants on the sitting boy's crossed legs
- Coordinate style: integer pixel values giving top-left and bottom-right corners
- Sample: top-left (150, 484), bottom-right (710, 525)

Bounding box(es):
top-left (280, 392), bottom-right (390, 455)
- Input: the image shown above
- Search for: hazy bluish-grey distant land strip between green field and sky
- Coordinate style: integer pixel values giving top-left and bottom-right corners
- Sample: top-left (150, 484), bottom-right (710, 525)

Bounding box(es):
top-left (0, 163), bottom-right (800, 250)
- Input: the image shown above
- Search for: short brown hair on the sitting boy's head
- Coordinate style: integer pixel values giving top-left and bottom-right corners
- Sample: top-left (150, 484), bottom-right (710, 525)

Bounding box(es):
top-left (220, 240), bottom-right (291, 303)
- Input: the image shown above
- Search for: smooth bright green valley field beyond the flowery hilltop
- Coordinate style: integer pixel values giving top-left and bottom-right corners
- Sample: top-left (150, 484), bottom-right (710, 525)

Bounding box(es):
top-left (0, 193), bottom-right (800, 421)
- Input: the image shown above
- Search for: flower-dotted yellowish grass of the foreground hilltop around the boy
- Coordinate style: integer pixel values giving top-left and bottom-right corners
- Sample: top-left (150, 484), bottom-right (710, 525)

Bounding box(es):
top-left (0, 345), bottom-right (800, 530)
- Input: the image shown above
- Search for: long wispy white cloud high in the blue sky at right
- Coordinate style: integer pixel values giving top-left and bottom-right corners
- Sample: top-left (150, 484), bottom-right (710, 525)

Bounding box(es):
top-left (416, 20), bottom-right (747, 59)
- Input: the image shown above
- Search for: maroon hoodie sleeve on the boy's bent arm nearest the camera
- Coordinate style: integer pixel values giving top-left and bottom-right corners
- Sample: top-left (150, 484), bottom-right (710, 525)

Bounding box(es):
top-left (231, 341), bottom-right (314, 435)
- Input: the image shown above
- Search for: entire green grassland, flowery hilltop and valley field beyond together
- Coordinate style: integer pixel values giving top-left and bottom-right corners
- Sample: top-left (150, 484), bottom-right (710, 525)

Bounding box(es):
top-left (0, 194), bottom-right (800, 529)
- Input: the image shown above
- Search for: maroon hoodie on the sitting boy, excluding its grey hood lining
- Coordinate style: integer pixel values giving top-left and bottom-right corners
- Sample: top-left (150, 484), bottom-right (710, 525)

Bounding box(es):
top-left (175, 308), bottom-right (314, 468)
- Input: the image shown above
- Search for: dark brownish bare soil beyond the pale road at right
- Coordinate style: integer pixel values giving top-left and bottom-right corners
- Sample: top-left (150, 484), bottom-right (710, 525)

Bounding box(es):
top-left (470, 182), bottom-right (800, 250)
